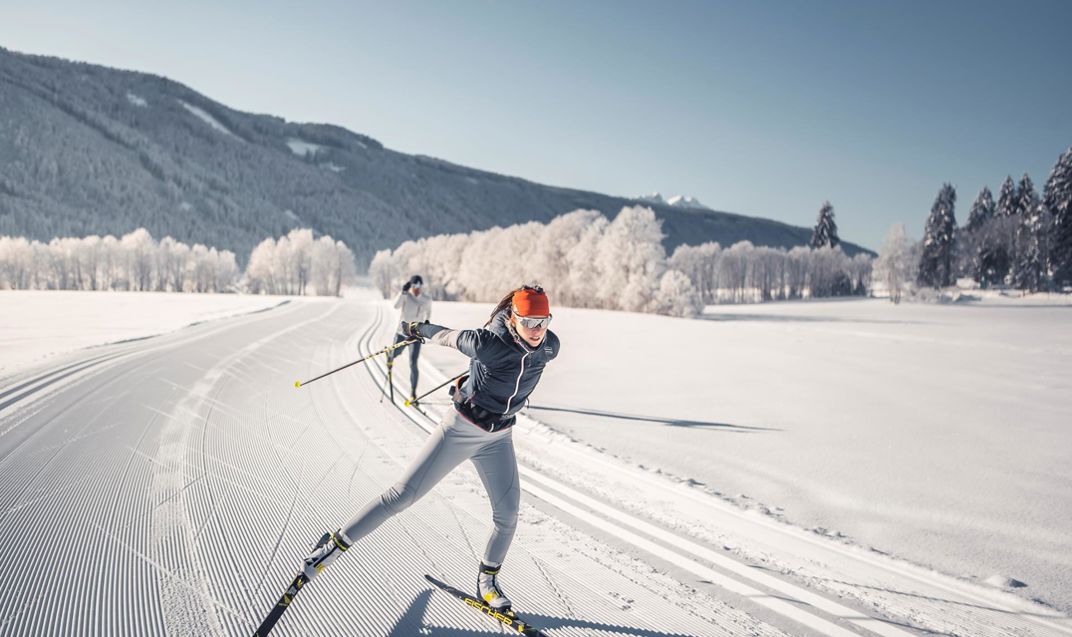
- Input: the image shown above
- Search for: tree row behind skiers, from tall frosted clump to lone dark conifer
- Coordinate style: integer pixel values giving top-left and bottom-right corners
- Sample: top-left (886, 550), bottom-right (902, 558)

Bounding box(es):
top-left (369, 204), bottom-right (870, 316)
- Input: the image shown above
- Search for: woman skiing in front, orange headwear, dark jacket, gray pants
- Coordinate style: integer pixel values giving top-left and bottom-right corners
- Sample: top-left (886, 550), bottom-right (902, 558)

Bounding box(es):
top-left (304, 285), bottom-right (559, 610)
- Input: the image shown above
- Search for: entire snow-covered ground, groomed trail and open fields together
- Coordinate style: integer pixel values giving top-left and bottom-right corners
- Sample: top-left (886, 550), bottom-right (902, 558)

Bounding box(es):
top-left (0, 290), bottom-right (1072, 637)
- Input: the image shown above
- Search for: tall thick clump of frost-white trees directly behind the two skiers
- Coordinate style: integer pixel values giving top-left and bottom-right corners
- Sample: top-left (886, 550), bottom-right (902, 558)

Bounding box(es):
top-left (369, 207), bottom-right (700, 313)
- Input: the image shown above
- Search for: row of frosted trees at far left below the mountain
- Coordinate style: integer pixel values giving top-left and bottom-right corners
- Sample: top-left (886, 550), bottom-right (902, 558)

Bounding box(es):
top-left (0, 228), bottom-right (356, 296)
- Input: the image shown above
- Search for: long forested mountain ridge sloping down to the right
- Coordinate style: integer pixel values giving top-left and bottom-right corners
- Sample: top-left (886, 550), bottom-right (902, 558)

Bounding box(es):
top-left (0, 47), bottom-right (869, 267)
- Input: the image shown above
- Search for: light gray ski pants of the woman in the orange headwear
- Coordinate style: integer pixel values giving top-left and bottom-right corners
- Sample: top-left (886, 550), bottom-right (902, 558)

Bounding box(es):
top-left (343, 409), bottom-right (521, 566)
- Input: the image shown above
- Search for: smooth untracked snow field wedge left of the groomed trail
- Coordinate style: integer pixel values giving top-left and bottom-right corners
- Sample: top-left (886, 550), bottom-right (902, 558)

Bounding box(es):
top-left (0, 290), bottom-right (289, 376)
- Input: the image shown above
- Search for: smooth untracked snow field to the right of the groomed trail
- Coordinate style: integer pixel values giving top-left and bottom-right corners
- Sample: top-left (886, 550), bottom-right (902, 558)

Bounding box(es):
top-left (423, 296), bottom-right (1072, 612)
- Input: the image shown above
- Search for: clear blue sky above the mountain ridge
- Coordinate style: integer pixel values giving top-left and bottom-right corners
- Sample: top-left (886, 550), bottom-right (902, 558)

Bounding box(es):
top-left (0, 0), bottom-right (1072, 249)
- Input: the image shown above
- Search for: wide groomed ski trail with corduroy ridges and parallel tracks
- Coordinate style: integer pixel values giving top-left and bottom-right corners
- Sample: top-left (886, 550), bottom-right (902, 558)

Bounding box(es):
top-left (0, 296), bottom-right (1072, 637)
